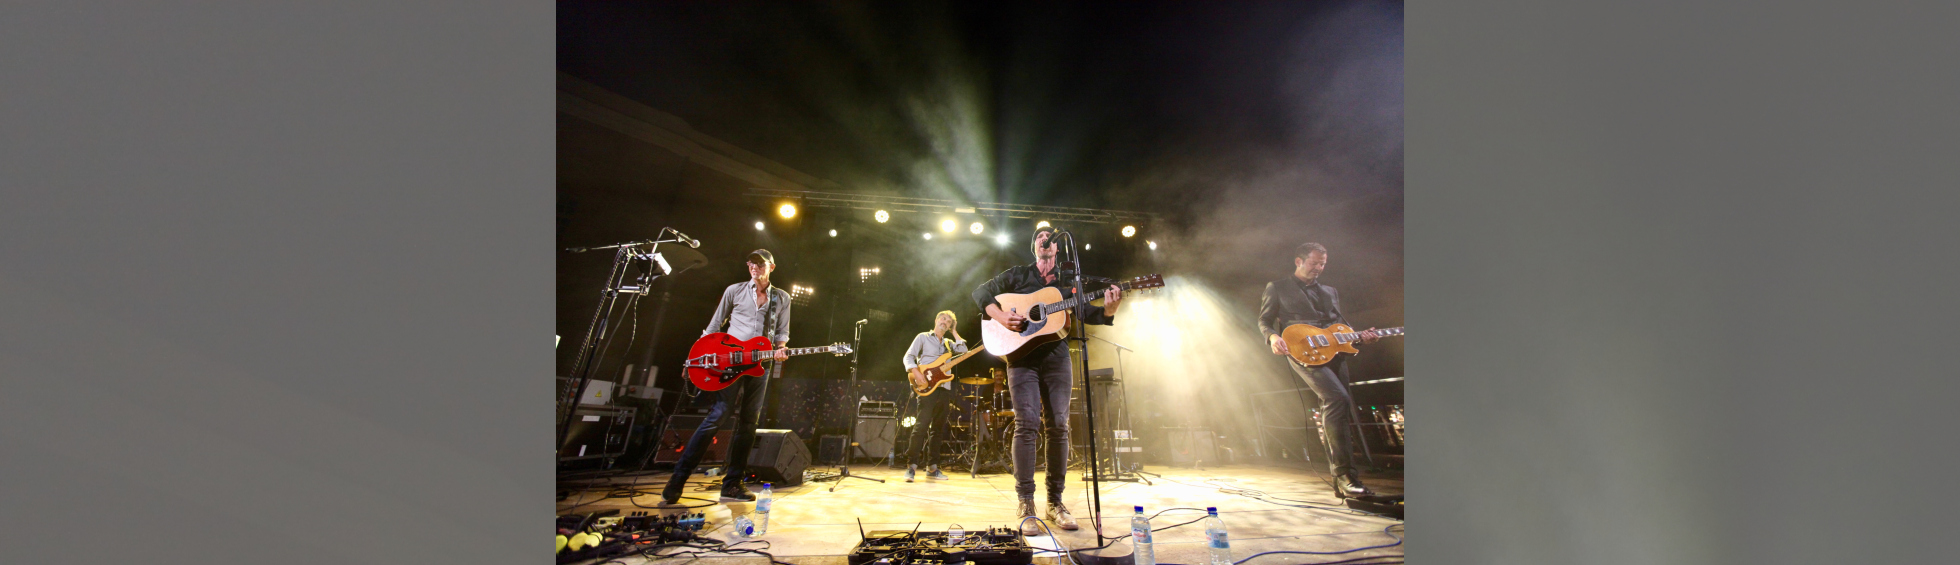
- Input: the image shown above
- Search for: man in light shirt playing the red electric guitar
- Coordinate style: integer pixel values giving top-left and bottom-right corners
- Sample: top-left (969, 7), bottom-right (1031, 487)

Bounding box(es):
top-left (661, 249), bottom-right (790, 504)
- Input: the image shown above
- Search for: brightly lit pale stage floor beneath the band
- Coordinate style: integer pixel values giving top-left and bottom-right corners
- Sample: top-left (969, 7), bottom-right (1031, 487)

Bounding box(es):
top-left (557, 463), bottom-right (1403, 565)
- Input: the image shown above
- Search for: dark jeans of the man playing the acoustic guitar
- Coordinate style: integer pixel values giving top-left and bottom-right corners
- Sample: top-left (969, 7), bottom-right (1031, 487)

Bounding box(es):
top-left (1007, 343), bottom-right (1074, 502)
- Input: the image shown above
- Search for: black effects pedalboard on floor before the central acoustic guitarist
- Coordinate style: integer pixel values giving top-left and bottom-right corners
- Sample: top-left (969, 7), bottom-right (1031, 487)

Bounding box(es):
top-left (845, 526), bottom-right (1035, 565)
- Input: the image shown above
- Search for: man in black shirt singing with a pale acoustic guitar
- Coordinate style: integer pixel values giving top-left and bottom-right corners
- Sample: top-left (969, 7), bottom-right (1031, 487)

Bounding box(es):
top-left (974, 228), bottom-right (1123, 536)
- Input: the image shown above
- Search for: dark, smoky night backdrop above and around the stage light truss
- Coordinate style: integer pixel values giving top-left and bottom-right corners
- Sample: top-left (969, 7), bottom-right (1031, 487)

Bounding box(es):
top-left (559, 2), bottom-right (1403, 396)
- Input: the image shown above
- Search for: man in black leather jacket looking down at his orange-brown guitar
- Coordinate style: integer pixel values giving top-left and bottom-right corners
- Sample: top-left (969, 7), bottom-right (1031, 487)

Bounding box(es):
top-left (1258, 243), bottom-right (1382, 498)
